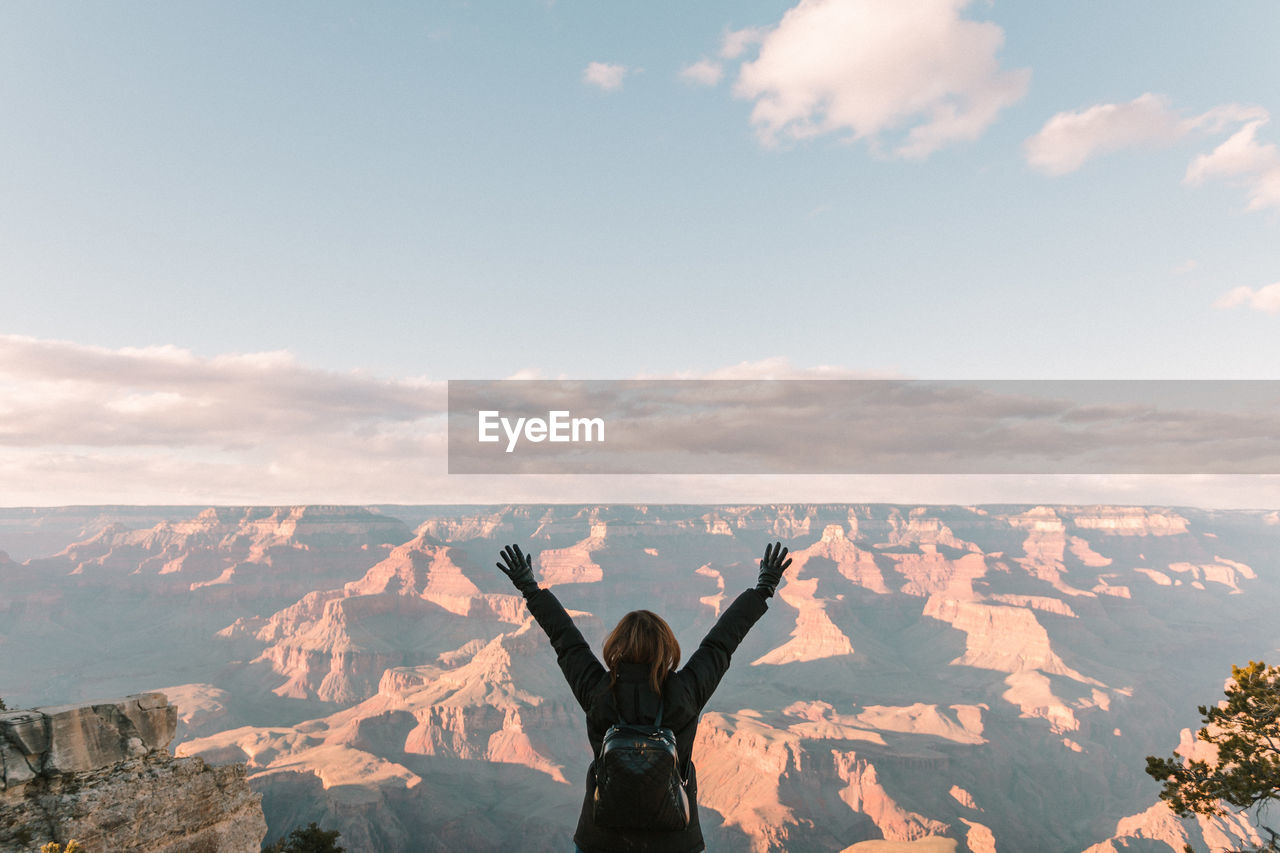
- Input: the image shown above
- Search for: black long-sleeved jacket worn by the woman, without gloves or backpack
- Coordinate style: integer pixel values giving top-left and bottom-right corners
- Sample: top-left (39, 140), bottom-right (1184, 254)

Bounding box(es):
top-left (527, 589), bottom-right (768, 853)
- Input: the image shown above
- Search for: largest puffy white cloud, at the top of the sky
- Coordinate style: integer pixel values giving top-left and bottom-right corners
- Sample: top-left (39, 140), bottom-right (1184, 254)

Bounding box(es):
top-left (722, 0), bottom-right (1030, 158)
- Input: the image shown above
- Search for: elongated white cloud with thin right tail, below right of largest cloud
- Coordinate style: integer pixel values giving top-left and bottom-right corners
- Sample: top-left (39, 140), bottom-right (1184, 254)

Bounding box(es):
top-left (1023, 92), bottom-right (1266, 174)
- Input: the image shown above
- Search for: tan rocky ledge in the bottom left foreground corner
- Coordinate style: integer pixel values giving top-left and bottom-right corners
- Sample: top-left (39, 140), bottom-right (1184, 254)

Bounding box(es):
top-left (0, 693), bottom-right (266, 853)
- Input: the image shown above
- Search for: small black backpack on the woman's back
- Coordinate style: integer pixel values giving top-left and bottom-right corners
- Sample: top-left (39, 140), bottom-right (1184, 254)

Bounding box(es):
top-left (593, 702), bottom-right (689, 830)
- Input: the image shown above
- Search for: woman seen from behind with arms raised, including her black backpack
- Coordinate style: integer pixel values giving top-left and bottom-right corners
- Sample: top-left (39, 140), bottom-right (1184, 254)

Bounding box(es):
top-left (497, 542), bottom-right (791, 853)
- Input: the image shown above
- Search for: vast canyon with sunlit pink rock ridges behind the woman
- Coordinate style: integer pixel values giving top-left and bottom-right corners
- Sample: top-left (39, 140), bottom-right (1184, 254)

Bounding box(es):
top-left (0, 505), bottom-right (1280, 853)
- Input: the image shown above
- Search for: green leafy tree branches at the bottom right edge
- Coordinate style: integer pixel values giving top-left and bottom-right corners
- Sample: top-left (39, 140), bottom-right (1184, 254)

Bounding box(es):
top-left (1147, 661), bottom-right (1280, 853)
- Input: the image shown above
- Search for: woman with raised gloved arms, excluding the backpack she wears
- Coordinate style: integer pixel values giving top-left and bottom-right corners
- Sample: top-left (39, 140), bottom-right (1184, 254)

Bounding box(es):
top-left (498, 542), bottom-right (791, 853)
